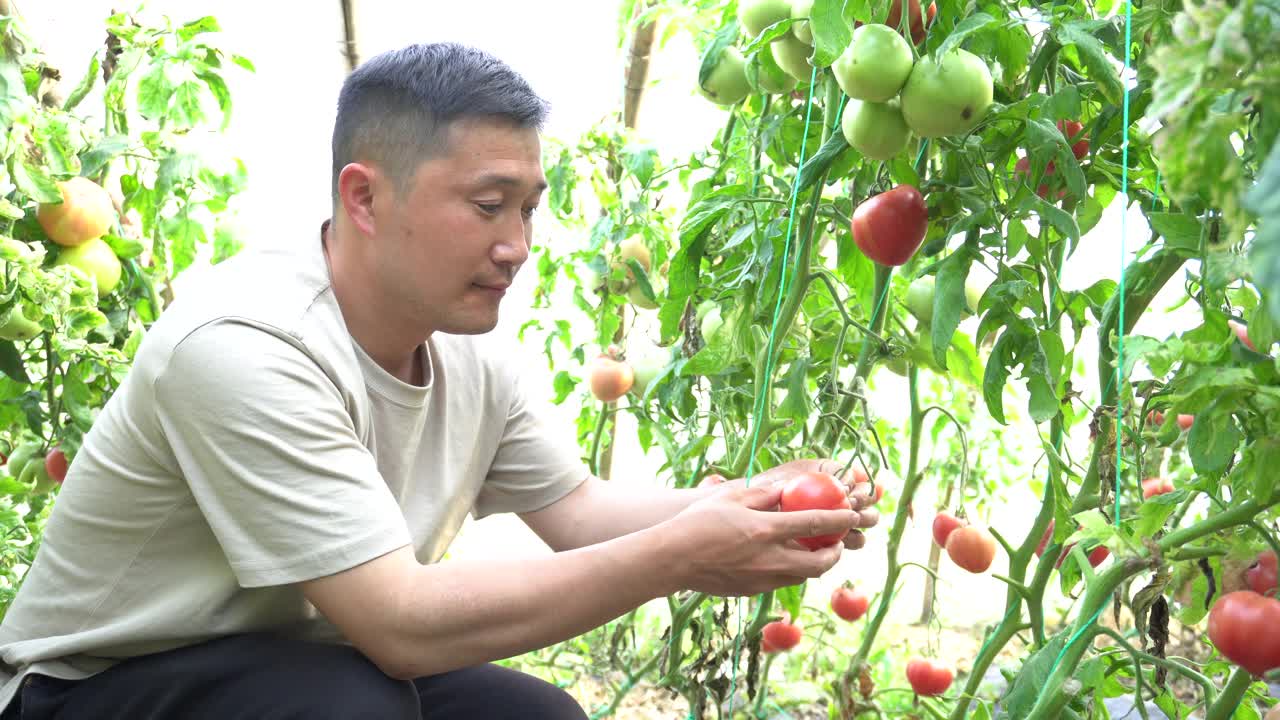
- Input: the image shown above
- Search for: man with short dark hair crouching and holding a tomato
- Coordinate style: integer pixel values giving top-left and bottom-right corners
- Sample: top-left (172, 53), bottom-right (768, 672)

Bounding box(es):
top-left (0, 45), bottom-right (877, 720)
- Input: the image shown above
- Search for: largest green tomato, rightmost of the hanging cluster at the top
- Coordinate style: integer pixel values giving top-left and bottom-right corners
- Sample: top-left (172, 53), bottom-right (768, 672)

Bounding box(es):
top-left (902, 49), bottom-right (992, 137)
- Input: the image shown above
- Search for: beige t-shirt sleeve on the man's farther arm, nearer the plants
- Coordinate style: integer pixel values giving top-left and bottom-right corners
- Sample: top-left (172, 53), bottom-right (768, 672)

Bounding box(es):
top-left (471, 363), bottom-right (589, 519)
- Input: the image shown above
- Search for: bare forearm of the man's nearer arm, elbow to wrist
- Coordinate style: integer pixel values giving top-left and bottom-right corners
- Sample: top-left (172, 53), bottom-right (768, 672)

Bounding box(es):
top-left (392, 515), bottom-right (680, 678)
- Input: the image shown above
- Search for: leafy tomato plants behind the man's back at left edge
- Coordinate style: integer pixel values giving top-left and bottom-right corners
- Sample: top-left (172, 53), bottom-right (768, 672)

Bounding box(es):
top-left (0, 7), bottom-right (253, 615)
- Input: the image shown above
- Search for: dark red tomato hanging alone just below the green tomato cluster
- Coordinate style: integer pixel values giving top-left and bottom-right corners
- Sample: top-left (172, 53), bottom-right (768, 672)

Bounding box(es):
top-left (850, 184), bottom-right (929, 266)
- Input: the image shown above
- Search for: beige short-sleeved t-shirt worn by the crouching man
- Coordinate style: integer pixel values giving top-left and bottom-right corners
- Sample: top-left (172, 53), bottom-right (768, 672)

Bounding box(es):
top-left (0, 225), bottom-right (588, 708)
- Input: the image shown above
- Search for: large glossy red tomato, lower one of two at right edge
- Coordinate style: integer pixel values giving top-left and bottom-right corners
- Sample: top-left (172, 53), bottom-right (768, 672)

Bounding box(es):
top-left (1208, 591), bottom-right (1280, 675)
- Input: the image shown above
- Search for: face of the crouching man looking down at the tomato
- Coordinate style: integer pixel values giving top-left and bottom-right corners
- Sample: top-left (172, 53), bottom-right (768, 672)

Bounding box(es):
top-left (374, 119), bottom-right (547, 334)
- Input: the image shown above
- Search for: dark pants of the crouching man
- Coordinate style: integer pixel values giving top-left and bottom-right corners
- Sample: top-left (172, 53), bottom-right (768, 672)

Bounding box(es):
top-left (3, 634), bottom-right (586, 720)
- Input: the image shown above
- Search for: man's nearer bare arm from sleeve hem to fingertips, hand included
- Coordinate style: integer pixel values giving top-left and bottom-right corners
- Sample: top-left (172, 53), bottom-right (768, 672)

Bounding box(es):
top-left (301, 486), bottom-right (858, 679)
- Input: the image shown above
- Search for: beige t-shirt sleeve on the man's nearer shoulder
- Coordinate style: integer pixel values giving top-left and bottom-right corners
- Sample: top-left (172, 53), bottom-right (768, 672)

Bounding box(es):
top-left (154, 320), bottom-right (411, 587)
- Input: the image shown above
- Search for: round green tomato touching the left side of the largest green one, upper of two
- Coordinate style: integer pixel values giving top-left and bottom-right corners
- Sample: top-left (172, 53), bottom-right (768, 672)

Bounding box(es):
top-left (831, 23), bottom-right (913, 102)
